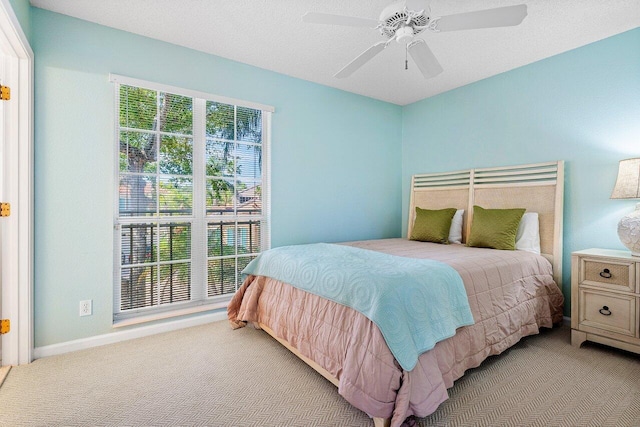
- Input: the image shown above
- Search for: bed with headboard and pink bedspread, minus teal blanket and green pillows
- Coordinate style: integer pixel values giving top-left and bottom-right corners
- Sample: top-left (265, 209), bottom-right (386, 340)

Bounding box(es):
top-left (228, 161), bottom-right (564, 426)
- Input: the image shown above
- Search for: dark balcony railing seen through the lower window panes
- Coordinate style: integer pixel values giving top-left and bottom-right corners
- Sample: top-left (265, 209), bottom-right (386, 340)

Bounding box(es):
top-left (120, 212), bottom-right (261, 310)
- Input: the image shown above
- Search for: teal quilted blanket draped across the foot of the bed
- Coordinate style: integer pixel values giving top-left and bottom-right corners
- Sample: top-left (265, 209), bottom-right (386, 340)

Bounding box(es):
top-left (242, 243), bottom-right (473, 371)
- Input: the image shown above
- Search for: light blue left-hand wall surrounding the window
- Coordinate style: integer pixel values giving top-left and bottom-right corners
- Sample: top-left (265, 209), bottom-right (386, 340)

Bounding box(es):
top-left (31, 8), bottom-right (402, 347)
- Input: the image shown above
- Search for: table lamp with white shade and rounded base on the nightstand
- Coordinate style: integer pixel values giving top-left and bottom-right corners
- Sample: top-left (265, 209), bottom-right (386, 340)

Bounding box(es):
top-left (611, 158), bottom-right (640, 257)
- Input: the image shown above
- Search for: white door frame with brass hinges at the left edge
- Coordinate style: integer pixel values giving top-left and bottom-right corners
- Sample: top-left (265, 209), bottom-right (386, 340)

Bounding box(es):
top-left (0, 0), bottom-right (34, 365)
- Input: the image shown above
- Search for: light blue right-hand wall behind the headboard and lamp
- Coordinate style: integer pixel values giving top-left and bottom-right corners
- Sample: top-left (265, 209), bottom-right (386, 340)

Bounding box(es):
top-left (402, 29), bottom-right (640, 314)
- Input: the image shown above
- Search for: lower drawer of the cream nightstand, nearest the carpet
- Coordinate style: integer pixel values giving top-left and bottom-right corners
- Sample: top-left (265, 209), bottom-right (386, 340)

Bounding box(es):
top-left (579, 289), bottom-right (636, 336)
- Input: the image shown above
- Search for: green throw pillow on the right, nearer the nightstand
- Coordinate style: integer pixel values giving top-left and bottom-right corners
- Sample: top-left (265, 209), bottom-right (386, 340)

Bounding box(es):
top-left (467, 206), bottom-right (526, 251)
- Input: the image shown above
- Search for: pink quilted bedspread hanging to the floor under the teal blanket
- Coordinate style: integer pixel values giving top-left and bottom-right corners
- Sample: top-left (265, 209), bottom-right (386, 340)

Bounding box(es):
top-left (228, 239), bottom-right (564, 426)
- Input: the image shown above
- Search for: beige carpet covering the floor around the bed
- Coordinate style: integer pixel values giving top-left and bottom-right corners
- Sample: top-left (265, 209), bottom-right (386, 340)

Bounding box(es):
top-left (0, 322), bottom-right (640, 426)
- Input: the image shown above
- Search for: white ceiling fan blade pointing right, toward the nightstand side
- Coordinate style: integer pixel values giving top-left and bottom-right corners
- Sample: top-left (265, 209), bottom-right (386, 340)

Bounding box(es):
top-left (436, 4), bottom-right (527, 31)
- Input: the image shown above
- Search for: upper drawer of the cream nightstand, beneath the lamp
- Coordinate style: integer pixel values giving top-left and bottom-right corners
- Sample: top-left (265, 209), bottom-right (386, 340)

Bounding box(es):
top-left (580, 258), bottom-right (636, 292)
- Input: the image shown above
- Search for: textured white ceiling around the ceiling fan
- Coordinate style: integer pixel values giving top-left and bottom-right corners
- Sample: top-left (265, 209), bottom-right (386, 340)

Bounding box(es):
top-left (31, 0), bottom-right (640, 105)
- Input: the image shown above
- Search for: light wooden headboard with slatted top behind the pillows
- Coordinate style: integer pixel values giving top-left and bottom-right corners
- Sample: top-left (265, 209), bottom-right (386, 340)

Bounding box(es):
top-left (407, 160), bottom-right (564, 286)
